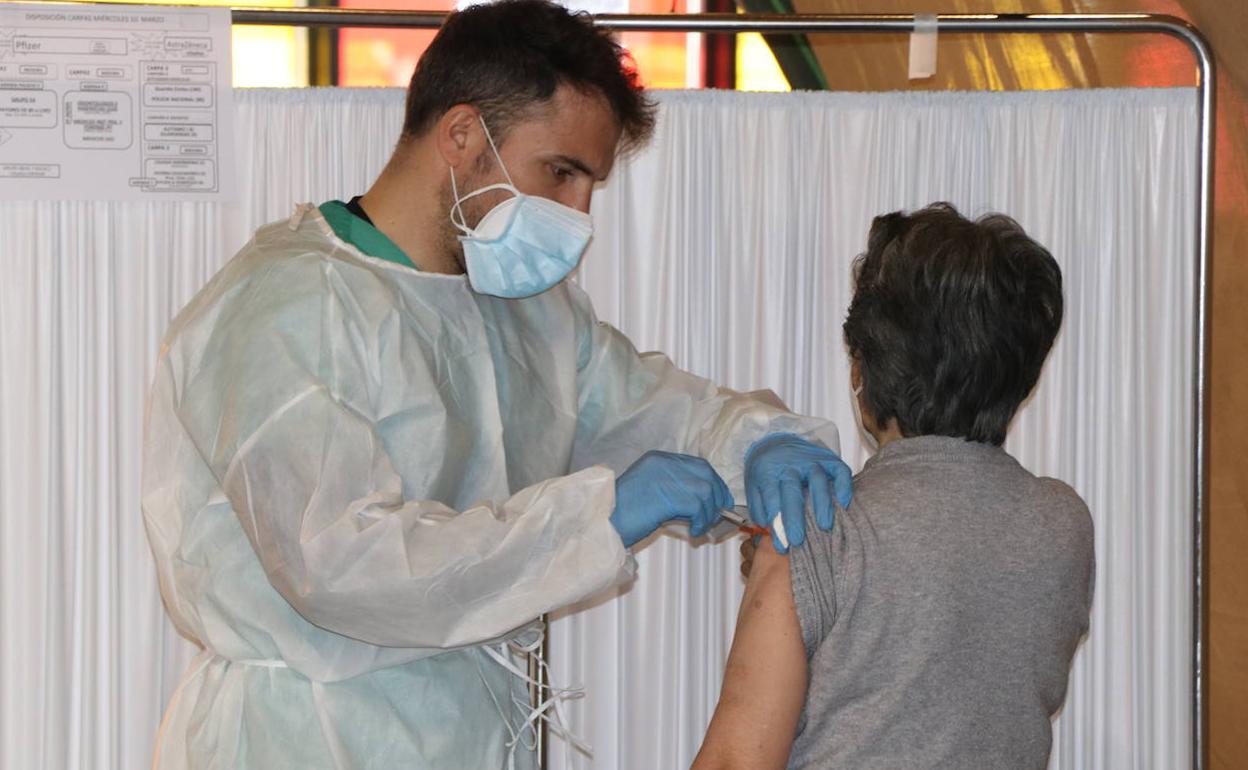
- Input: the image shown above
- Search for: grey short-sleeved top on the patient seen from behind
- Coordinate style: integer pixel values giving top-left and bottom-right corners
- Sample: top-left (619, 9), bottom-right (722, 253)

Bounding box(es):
top-left (789, 436), bottom-right (1093, 770)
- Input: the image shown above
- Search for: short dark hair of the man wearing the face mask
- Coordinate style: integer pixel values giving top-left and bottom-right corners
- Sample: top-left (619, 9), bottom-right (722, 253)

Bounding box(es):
top-left (403, 0), bottom-right (654, 150)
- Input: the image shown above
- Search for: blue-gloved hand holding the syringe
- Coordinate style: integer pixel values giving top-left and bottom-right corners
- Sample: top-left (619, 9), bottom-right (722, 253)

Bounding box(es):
top-left (612, 452), bottom-right (733, 548)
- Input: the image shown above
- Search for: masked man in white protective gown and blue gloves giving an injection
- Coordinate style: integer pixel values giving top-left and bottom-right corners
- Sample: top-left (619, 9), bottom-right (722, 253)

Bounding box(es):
top-left (142, 0), bottom-right (849, 770)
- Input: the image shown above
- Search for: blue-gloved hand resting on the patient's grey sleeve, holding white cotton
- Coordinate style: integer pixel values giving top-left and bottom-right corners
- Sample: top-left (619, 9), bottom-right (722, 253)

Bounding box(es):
top-left (745, 433), bottom-right (854, 553)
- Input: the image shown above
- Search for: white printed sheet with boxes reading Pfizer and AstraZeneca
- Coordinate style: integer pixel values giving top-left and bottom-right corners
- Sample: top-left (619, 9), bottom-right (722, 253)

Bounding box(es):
top-left (0, 4), bottom-right (233, 201)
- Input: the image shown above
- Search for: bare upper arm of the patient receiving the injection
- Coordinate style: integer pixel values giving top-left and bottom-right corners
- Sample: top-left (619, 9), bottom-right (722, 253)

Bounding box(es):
top-left (693, 538), bottom-right (807, 770)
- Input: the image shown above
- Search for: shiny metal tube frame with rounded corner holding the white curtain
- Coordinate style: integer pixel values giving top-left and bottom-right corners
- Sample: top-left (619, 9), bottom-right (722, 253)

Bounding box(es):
top-left (46, 6), bottom-right (1217, 770)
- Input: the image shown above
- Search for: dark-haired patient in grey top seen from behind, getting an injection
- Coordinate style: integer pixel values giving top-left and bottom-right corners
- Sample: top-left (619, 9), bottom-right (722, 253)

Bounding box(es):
top-left (694, 205), bottom-right (1093, 770)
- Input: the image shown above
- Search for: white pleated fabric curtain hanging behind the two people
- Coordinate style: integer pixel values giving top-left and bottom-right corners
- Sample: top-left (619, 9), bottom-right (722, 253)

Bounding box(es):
top-left (0, 90), bottom-right (1196, 770)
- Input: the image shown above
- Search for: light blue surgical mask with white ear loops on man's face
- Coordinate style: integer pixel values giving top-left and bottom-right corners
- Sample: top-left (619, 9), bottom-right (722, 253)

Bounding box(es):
top-left (451, 120), bottom-right (594, 300)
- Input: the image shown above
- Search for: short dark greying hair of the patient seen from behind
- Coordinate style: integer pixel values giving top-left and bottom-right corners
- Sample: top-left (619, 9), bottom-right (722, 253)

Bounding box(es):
top-left (845, 203), bottom-right (1062, 446)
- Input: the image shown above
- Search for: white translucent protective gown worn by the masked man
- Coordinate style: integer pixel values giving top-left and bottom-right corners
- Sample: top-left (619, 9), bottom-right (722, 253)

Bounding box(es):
top-left (142, 207), bottom-right (837, 770)
